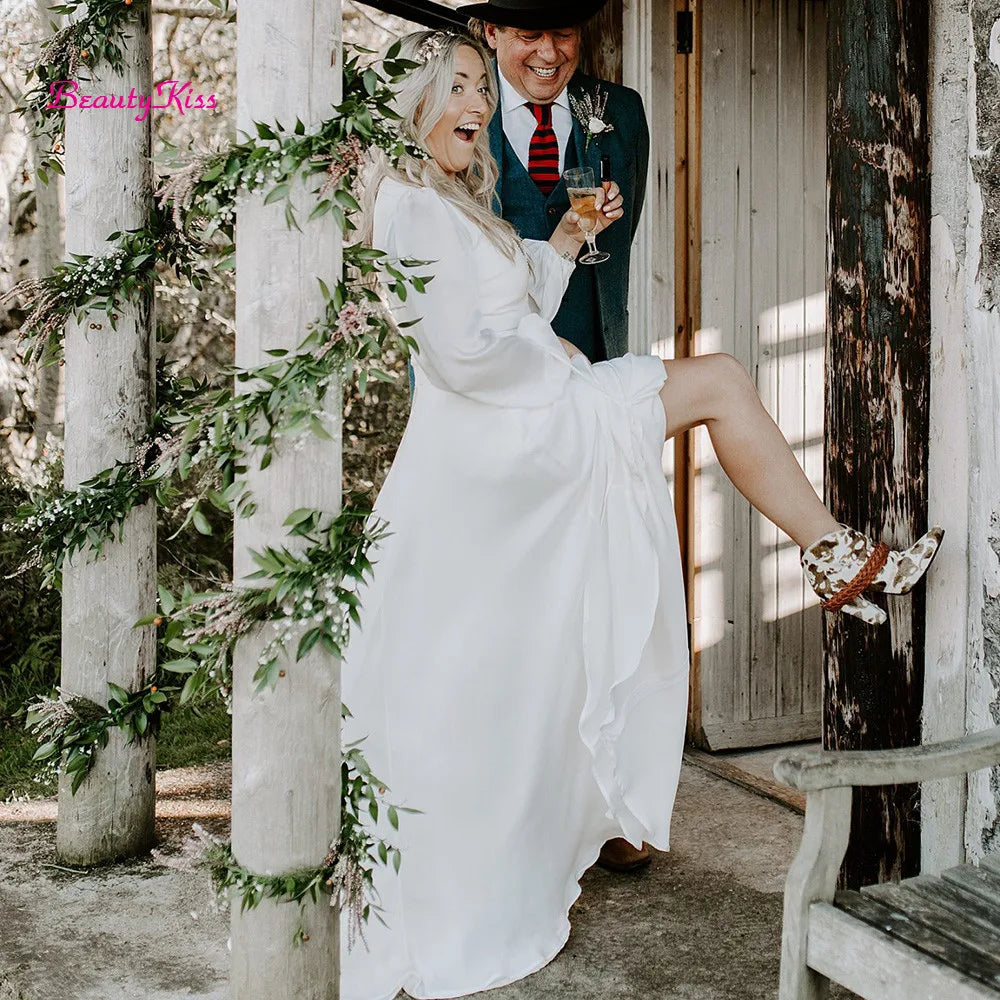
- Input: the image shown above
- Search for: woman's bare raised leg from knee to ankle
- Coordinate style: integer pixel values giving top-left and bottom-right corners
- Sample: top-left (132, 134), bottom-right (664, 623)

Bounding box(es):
top-left (660, 354), bottom-right (840, 548)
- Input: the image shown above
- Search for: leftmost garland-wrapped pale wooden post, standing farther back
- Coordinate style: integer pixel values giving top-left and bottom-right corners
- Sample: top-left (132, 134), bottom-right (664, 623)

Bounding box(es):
top-left (56, 2), bottom-right (156, 864)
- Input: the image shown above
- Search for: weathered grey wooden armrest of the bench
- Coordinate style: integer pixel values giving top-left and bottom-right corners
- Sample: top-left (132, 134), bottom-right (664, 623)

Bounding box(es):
top-left (774, 726), bottom-right (1000, 792)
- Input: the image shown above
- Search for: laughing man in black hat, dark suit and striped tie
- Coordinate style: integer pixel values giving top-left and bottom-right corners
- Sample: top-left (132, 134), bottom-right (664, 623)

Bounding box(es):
top-left (459, 0), bottom-right (650, 871)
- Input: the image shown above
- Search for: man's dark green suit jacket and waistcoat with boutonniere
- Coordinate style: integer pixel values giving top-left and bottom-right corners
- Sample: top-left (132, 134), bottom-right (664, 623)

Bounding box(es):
top-left (489, 73), bottom-right (649, 361)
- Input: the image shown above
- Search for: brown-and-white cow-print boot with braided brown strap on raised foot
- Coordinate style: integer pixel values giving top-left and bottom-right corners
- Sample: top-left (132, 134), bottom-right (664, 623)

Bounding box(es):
top-left (802, 524), bottom-right (944, 625)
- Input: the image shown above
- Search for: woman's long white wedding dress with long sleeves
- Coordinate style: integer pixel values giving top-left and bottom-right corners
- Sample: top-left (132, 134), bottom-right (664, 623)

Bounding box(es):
top-left (341, 179), bottom-right (688, 1000)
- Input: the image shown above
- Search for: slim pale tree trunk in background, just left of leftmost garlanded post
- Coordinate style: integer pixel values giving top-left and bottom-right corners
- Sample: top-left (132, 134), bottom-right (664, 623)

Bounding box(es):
top-left (31, 0), bottom-right (65, 458)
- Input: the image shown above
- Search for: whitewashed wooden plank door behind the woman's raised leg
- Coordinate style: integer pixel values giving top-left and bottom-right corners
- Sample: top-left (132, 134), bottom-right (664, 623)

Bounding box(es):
top-left (687, 0), bottom-right (826, 749)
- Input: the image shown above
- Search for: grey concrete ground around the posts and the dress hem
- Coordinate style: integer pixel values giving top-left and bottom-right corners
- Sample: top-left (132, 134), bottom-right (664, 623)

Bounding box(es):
top-left (0, 765), bottom-right (852, 1000)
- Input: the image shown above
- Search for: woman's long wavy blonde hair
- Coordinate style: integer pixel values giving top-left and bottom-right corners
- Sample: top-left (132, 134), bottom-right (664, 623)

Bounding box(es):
top-left (359, 31), bottom-right (520, 260)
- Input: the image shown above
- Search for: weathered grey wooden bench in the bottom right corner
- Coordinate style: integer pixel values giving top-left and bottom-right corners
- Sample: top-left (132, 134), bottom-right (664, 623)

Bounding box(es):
top-left (774, 727), bottom-right (1000, 1000)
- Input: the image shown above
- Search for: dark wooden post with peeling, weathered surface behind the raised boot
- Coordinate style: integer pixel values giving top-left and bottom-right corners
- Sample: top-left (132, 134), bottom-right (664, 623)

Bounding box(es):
top-left (824, 0), bottom-right (930, 887)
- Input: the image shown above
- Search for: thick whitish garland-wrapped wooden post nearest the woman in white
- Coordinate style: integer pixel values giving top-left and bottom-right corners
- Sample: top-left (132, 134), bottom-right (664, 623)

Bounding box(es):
top-left (231, 0), bottom-right (341, 1000)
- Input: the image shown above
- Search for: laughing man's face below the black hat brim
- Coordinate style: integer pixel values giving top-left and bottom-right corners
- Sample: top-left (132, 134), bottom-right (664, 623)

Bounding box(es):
top-left (485, 24), bottom-right (580, 104)
